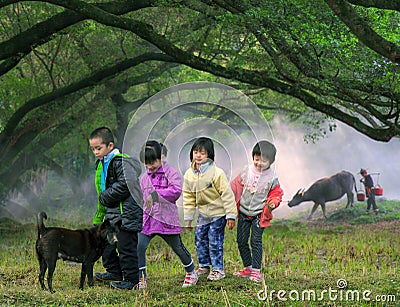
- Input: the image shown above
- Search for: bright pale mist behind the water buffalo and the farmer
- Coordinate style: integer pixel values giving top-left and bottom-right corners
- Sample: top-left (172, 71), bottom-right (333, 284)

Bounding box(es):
top-left (271, 120), bottom-right (400, 217)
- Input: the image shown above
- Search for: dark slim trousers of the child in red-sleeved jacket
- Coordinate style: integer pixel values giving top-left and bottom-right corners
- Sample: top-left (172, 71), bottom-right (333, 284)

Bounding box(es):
top-left (236, 213), bottom-right (264, 269)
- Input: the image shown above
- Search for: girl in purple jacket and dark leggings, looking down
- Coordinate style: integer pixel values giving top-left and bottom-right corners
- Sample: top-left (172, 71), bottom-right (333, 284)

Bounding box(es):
top-left (138, 141), bottom-right (198, 288)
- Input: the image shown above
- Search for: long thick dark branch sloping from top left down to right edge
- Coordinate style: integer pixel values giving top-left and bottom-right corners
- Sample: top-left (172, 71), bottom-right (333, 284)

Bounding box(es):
top-left (4, 0), bottom-right (399, 141)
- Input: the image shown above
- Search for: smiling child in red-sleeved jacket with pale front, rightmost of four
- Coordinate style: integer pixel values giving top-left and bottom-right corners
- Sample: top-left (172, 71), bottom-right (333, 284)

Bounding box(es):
top-left (231, 140), bottom-right (283, 282)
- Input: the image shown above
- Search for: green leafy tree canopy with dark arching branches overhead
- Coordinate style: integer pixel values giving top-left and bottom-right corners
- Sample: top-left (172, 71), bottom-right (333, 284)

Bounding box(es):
top-left (0, 0), bottom-right (400, 207)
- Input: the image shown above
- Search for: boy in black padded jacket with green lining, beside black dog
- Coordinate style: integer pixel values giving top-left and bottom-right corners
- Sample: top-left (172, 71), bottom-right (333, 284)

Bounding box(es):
top-left (89, 127), bottom-right (143, 290)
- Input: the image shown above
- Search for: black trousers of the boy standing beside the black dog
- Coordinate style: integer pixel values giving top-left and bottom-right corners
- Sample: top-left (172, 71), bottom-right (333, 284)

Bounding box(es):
top-left (102, 229), bottom-right (139, 284)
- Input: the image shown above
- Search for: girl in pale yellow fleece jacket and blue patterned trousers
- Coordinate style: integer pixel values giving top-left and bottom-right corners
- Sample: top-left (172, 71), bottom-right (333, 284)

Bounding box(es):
top-left (183, 137), bottom-right (237, 281)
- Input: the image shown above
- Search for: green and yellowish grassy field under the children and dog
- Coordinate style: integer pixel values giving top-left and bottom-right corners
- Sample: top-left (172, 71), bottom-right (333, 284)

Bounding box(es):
top-left (0, 201), bottom-right (400, 306)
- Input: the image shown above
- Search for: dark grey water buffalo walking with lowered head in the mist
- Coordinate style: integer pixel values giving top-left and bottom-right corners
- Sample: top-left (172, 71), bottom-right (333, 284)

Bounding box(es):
top-left (288, 171), bottom-right (357, 219)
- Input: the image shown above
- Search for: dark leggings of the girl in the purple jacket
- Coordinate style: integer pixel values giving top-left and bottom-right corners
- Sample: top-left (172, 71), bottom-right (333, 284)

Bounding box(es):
top-left (138, 233), bottom-right (194, 278)
